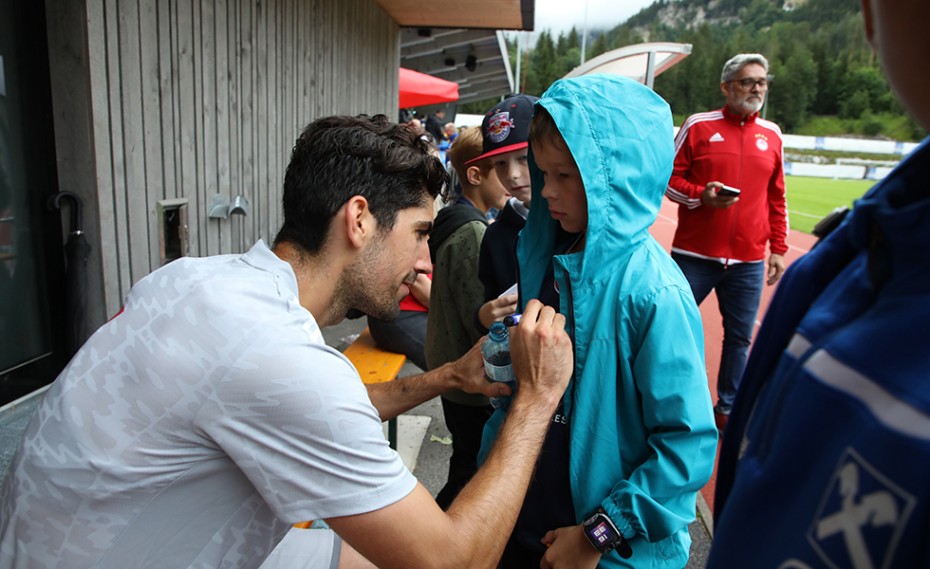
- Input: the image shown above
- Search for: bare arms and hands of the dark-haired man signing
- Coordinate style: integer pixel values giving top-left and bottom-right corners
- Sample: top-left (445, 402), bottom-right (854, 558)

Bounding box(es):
top-left (328, 300), bottom-right (573, 569)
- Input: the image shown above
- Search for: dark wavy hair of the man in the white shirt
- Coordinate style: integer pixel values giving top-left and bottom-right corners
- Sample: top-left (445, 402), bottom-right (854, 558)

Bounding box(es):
top-left (274, 115), bottom-right (449, 254)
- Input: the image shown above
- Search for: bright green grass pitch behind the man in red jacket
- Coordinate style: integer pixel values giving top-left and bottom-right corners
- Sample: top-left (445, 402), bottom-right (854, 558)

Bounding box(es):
top-left (785, 176), bottom-right (875, 233)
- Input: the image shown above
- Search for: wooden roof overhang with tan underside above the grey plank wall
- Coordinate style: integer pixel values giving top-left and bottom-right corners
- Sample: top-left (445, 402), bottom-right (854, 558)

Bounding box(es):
top-left (375, 0), bottom-right (536, 31)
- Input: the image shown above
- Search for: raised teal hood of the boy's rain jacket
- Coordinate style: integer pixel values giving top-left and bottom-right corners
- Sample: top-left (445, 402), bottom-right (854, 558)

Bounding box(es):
top-left (521, 75), bottom-right (675, 298)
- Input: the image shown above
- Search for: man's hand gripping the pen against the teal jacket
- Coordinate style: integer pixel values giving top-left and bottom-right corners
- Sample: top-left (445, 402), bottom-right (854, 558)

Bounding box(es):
top-left (510, 299), bottom-right (574, 403)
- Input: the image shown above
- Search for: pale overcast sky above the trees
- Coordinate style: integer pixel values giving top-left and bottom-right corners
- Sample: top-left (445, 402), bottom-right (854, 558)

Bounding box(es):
top-left (535, 0), bottom-right (653, 39)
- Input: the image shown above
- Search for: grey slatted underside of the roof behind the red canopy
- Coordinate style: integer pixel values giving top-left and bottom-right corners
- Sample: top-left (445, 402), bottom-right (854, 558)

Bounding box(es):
top-left (400, 28), bottom-right (513, 104)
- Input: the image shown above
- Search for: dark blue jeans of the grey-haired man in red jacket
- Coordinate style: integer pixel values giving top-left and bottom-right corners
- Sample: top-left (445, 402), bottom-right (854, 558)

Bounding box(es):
top-left (672, 253), bottom-right (765, 414)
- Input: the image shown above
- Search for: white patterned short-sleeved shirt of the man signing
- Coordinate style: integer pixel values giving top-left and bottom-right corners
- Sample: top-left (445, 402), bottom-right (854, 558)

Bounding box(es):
top-left (0, 241), bottom-right (416, 569)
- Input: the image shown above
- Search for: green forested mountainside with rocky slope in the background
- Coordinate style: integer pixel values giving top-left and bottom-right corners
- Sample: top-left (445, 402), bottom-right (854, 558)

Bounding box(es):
top-left (467, 0), bottom-right (924, 140)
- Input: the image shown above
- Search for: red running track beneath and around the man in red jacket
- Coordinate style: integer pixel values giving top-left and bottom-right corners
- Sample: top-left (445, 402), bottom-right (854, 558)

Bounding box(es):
top-left (650, 200), bottom-right (816, 512)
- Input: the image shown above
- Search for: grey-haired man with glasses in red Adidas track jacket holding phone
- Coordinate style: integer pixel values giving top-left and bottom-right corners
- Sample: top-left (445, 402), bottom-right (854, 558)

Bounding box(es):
top-left (666, 54), bottom-right (788, 430)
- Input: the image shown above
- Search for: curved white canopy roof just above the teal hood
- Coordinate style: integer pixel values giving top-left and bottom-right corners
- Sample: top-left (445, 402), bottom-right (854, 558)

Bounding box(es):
top-left (565, 42), bottom-right (691, 88)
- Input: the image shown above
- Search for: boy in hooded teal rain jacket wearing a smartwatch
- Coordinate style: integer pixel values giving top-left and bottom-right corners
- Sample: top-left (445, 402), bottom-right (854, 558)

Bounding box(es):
top-left (482, 75), bottom-right (717, 569)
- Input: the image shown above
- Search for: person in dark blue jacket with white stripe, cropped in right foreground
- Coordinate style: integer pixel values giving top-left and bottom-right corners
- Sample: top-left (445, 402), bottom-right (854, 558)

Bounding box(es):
top-left (708, 0), bottom-right (930, 569)
